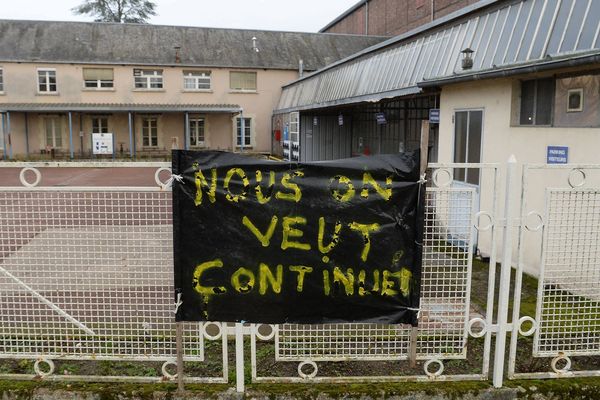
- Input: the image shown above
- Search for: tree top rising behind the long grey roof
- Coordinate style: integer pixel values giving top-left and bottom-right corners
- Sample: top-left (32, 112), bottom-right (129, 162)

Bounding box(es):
top-left (71, 0), bottom-right (156, 24)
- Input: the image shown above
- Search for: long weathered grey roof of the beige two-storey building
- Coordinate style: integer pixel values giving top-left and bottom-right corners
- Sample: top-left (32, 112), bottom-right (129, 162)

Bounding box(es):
top-left (0, 20), bottom-right (386, 71)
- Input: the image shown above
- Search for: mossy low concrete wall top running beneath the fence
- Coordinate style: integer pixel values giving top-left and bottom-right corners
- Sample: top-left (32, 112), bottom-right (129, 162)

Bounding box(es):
top-left (0, 378), bottom-right (600, 400)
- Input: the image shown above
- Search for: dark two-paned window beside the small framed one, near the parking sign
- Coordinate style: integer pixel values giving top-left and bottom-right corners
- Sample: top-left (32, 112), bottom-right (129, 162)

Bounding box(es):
top-left (519, 78), bottom-right (554, 125)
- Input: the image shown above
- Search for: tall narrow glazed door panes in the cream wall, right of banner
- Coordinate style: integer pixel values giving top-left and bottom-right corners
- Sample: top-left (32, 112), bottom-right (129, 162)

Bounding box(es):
top-left (454, 110), bottom-right (483, 185)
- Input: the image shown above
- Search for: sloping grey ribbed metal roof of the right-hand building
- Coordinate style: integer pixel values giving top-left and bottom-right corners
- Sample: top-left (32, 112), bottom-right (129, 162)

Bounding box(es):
top-left (278, 0), bottom-right (600, 111)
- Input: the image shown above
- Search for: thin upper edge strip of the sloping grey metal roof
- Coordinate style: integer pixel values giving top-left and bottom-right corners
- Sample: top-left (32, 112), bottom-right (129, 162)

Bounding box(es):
top-left (282, 0), bottom-right (502, 88)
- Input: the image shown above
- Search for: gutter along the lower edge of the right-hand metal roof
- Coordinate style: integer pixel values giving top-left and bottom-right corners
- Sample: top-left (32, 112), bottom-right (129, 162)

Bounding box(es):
top-left (417, 53), bottom-right (600, 88)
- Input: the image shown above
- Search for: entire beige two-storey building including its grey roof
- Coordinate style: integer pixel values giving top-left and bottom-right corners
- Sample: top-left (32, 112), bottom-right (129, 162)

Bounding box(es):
top-left (0, 20), bottom-right (383, 159)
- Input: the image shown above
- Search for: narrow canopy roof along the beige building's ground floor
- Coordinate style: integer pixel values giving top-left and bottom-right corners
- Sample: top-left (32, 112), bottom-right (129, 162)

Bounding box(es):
top-left (0, 103), bottom-right (242, 113)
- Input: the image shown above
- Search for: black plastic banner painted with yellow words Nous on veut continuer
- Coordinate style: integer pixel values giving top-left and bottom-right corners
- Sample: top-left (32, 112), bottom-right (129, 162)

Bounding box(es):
top-left (173, 150), bottom-right (425, 325)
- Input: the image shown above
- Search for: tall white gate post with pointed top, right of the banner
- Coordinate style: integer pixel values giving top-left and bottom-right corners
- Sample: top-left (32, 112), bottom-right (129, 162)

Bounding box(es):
top-left (493, 155), bottom-right (517, 388)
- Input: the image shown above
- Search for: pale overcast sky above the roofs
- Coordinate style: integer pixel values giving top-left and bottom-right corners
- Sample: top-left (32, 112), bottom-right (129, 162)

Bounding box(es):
top-left (0, 0), bottom-right (358, 32)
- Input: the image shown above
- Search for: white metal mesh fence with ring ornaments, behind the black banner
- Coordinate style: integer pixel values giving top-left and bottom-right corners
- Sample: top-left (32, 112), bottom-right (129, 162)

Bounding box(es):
top-left (0, 163), bottom-right (600, 390)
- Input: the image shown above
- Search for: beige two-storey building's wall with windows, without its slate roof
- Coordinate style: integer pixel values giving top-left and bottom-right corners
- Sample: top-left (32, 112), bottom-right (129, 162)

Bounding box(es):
top-left (0, 63), bottom-right (297, 158)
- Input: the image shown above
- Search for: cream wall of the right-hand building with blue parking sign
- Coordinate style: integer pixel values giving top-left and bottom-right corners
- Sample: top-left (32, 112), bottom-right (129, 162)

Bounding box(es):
top-left (439, 79), bottom-right (600, 275)
